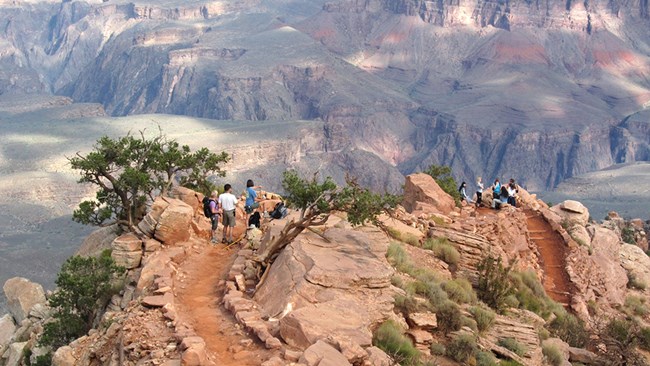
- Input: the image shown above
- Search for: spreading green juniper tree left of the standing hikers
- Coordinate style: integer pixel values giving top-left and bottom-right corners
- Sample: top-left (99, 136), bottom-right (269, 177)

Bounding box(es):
top-left (68, 131), bottom-right (228, 231)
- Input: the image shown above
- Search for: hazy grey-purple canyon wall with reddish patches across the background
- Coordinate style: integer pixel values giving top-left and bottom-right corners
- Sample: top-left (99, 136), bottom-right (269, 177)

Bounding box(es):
top-left (0, 0), bottom-right (650, 189)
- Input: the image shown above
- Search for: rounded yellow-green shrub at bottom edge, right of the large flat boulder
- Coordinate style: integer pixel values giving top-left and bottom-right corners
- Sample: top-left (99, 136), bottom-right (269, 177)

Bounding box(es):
top-left (372, 320), bottom-right (420, 366)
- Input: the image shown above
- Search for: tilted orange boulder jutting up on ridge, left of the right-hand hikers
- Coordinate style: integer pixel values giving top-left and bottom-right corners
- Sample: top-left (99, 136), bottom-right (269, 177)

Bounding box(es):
top-left (402, 173), bottom-right (456, 214)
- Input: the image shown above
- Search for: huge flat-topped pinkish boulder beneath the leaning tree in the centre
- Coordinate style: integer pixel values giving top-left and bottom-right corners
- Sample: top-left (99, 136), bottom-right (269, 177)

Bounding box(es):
top-left (255, 228), bottom-right (394, 350)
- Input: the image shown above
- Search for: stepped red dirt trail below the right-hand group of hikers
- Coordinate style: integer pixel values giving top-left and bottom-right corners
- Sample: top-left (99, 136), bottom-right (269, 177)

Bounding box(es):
top-left (524, 210), bottom-right (573, 307)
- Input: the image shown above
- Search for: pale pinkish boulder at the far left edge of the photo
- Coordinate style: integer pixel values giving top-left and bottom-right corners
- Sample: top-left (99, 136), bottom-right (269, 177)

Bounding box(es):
top-left (2, 277), bottom-right (46, 323)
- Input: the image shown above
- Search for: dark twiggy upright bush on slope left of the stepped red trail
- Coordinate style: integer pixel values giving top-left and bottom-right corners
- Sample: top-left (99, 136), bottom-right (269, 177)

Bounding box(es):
top-left (477, 256), bottom-right (513, 311)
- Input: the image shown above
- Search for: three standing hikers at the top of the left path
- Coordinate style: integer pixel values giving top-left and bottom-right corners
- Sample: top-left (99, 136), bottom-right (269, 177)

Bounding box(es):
top-left (204, 179), bottom-right (262, 244)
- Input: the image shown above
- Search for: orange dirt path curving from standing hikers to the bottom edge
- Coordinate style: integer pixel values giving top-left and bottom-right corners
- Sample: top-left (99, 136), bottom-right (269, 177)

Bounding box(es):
top-left (175, 240), bottom-right (271, 366)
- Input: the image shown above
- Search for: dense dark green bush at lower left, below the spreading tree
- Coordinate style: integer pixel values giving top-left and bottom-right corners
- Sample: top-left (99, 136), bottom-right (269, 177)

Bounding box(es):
top-left (39, 251), bottom-right (124, 349)
